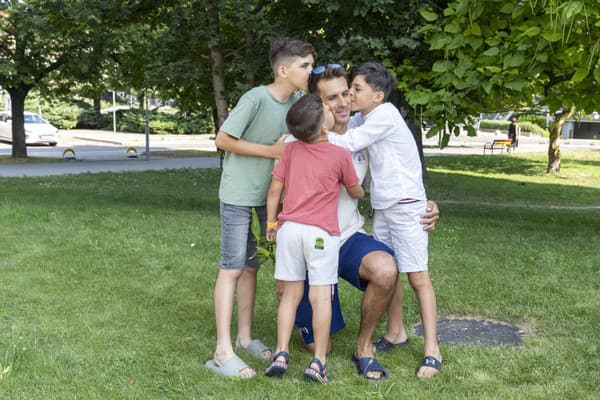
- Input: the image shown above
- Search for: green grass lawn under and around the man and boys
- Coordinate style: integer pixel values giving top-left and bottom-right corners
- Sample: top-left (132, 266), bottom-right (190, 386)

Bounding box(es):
top-left (0, 151), bottom-right (600, 400)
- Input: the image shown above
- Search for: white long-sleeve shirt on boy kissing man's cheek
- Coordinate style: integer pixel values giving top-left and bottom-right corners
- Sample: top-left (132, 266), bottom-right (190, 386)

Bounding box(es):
top-left (328, 103), bottom-right (427, 210)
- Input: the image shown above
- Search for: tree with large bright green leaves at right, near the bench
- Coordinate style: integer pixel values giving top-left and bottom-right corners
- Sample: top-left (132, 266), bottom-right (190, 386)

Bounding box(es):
top-left (413, 0), bottom-right (600, 172)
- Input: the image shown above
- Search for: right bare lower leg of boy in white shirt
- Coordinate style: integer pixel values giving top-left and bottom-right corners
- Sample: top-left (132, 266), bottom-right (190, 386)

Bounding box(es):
top-left (408, 271), bottom-right (442, 378)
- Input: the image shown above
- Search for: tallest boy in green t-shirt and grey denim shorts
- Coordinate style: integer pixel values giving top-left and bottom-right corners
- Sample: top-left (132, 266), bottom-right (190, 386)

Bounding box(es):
top-left (206, 38), bottom-right (316, 378)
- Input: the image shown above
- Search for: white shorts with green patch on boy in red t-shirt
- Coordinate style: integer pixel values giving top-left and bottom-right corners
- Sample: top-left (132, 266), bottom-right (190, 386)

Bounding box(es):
top-left (275, 221), bottom-right (340, 286)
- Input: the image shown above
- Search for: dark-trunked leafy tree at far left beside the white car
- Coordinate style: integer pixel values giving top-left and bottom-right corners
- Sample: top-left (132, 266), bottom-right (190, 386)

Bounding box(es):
top-left (0, 0), bottom-right (157, 157)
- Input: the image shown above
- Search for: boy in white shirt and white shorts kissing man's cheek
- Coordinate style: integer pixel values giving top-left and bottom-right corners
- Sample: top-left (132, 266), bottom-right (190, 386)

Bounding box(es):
top-left (329, 62), bottom-right (442, 377)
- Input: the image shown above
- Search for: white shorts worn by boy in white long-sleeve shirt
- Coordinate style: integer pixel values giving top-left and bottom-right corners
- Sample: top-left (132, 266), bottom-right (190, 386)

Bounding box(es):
top-left (373, 201), bottom-right (429, 272)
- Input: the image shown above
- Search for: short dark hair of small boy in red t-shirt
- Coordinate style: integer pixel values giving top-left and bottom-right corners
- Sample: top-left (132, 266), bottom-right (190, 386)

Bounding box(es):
top-left (285, 94), bottom-right (325, 143)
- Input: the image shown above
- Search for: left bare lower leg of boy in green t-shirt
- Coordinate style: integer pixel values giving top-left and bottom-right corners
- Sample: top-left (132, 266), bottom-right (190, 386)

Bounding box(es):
top-left (214, 269), bottom-right (256, 378)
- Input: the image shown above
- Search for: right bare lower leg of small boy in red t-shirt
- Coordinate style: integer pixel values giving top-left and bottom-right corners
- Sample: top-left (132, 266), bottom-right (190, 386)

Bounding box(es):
top-left (308, 285), bottom-right (331, 367)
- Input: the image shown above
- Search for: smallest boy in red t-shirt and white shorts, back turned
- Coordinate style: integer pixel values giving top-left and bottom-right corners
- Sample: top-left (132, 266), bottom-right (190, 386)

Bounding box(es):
top-left (265, 94), bottom-right (364, 383)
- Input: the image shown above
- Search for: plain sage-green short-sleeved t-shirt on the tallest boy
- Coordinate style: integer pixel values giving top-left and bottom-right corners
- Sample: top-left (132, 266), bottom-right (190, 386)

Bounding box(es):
top-left (219, 86), bottom-right (297, 206)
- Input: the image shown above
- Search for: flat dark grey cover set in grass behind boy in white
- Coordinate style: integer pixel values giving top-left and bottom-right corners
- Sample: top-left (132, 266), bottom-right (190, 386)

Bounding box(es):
top-left (413, 318), bottom-right (525, 347)
